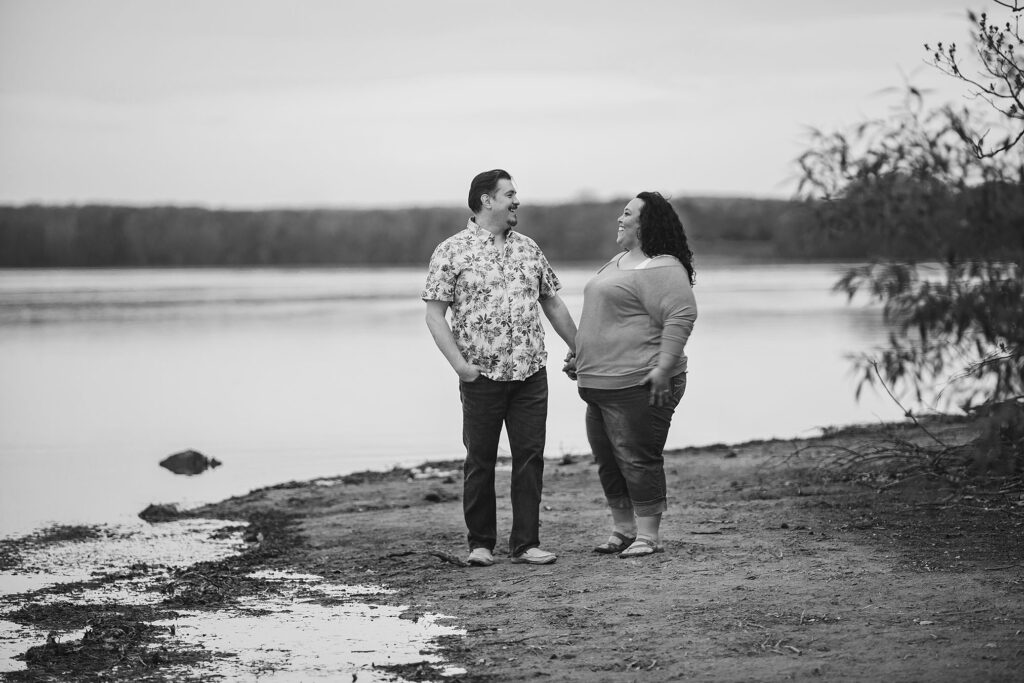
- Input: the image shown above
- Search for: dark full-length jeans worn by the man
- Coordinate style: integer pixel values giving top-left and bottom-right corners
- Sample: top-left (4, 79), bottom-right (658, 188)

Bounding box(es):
top-left (459, 368), bottom-right (548, 556)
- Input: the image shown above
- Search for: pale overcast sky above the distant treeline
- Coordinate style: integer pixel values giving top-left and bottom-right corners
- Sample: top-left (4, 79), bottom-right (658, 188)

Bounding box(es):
top-left (0, 0), bottom-right (986, 207)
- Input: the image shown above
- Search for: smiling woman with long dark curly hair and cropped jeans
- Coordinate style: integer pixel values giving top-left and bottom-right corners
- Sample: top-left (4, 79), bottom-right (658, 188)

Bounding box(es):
top-left (566, 193), bottom-right (697, 557)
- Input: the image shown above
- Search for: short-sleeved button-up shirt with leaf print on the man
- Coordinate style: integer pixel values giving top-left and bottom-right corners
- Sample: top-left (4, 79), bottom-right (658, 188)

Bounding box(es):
top-left (422, 218), bottom-right (561, 382)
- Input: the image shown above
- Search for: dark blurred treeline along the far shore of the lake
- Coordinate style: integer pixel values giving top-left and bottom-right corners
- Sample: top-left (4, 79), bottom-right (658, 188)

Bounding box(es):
top-left (0, 191), bottom-right (1015, 267)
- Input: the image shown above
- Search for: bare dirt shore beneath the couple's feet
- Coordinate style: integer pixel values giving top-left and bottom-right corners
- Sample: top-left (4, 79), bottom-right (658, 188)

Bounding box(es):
top-left (2, 413), bottom-right (1024, 681)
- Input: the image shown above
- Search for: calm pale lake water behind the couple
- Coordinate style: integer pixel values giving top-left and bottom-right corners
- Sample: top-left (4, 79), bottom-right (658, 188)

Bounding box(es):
top-left (0, 264), bottom-right (900, 536)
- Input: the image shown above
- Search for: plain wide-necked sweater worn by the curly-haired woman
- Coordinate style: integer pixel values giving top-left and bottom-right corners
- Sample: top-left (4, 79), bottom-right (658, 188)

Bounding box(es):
top-left (575, 256), bottom-right (697, 389)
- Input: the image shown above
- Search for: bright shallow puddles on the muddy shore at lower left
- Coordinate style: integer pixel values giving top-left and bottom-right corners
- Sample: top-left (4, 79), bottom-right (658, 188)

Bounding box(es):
top-left (0, 532), bottom-right (465, 683)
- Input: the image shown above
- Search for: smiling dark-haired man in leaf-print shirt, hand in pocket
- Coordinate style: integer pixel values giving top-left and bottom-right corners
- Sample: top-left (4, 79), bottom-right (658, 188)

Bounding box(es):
top-left (423, 169), bottom-right (575, 566)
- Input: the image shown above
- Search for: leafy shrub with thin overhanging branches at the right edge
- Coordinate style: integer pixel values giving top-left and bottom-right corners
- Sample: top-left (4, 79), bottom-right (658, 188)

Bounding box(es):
top-left (799, 0), bottom-right (1024, 486)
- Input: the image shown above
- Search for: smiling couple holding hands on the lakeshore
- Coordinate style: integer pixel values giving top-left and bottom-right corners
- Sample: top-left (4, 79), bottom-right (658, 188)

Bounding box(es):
top-left (422, 169), bottom-right (697, 566)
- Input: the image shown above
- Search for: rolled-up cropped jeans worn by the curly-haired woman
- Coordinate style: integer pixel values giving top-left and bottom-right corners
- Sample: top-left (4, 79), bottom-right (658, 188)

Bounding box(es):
top-left (580, 373), bottom-right (686, 517)
